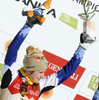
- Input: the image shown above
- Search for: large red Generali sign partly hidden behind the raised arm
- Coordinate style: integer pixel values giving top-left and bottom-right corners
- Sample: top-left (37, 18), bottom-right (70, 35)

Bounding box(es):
top-left (43, 50), bottom-right (85, 89)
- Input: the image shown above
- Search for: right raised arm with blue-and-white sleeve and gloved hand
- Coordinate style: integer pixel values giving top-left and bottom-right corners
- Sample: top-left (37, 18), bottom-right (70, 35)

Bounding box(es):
top-left (40, 33), bottom-right (94, 94)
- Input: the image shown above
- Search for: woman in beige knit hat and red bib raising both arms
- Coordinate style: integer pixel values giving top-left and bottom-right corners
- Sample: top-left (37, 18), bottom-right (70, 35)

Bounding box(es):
top-left (0, 1), bottom-right (95, 100)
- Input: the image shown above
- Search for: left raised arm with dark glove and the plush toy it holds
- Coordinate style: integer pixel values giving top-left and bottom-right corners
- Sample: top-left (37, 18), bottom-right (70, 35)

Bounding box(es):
top-left (1, 8), bottom-right (45, 88)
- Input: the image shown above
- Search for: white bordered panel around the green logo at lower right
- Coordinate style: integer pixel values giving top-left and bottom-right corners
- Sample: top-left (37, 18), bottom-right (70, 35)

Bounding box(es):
top-left (79, 71), bottom-right (98, 98)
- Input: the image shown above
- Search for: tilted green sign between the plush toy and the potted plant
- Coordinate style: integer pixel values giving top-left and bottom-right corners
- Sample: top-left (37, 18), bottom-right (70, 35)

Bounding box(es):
top-left (59, 13), bottom-right (78, 30)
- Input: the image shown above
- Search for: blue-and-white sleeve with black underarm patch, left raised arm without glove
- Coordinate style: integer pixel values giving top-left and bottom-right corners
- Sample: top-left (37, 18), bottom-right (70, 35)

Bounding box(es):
top-left (1, 24), bottom-right (31, 88)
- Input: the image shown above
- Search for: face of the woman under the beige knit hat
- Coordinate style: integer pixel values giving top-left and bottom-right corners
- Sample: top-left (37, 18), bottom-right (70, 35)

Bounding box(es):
top-left (28, 70), bottom-right (45, 83)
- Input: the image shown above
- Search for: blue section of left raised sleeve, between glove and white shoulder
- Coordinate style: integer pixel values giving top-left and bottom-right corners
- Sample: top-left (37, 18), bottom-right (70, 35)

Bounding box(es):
top-left (5, 24), bottom-right (31, 67)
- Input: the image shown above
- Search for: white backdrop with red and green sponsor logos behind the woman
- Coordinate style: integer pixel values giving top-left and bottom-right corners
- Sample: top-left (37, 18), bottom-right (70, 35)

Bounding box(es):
top-left (0, 0), bottom-right (99, 100)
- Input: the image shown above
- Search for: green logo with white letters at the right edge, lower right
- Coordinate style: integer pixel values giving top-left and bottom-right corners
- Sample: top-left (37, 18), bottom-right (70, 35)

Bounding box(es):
top-left (88, 75), bottom-right (98, 91)
